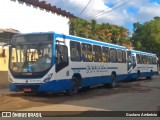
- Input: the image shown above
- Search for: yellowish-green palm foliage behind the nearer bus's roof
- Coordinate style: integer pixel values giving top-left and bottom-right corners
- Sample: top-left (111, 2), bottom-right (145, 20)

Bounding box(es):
top-left (70, 18), bottom-right (131, 45)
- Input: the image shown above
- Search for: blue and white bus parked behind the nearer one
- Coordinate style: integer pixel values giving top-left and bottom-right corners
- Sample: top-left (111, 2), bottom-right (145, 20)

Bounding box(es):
top-left (127, 50), bottom-right (158, 80)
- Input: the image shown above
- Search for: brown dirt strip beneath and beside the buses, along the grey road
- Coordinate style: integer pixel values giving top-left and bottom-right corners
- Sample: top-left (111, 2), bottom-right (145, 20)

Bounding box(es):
top-left (0, 75), bottom-right (159, 111)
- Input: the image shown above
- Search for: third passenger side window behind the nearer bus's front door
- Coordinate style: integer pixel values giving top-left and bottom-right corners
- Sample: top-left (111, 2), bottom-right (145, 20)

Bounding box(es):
top-left (93, 45), bottom-right (102, 62)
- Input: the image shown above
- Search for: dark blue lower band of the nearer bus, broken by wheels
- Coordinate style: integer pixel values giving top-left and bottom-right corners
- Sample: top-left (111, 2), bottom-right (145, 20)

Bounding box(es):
top-left (10, 74), bottom-right (127, 92)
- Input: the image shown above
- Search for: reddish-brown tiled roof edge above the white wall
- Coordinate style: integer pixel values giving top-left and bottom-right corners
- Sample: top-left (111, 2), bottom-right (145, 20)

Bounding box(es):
top-left (18, 0), bottom-right (75, 17)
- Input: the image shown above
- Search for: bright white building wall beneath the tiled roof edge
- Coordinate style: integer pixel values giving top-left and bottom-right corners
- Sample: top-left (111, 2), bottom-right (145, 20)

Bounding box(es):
top-left (0, 0), bottom-right (69, 34)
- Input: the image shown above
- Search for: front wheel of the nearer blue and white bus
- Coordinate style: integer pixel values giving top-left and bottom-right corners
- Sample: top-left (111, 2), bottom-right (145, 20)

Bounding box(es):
top-left (67, 78), bottom-right (79, 96)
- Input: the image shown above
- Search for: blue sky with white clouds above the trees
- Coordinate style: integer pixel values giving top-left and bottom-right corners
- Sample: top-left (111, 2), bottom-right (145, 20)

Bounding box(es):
top-left (40, 0), bottom-right (160, 33)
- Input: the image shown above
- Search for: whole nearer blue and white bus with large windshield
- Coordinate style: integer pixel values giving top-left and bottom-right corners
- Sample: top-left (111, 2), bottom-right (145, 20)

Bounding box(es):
top-left (4, 32), bottom-right (128, 95)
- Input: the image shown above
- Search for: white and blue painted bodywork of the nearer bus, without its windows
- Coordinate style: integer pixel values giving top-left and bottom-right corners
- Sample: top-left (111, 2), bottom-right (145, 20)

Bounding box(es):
top-left (9, 33), bottom-right (132, 92)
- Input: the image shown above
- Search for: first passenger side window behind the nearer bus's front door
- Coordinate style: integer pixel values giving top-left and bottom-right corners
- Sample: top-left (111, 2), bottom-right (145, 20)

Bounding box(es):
top-left (70, 41), bottom-right (81, 61)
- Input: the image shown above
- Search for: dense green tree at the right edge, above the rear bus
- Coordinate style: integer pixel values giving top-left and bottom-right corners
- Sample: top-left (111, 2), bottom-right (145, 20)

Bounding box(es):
top-left (132, 17), bottom-right (160, 53)
